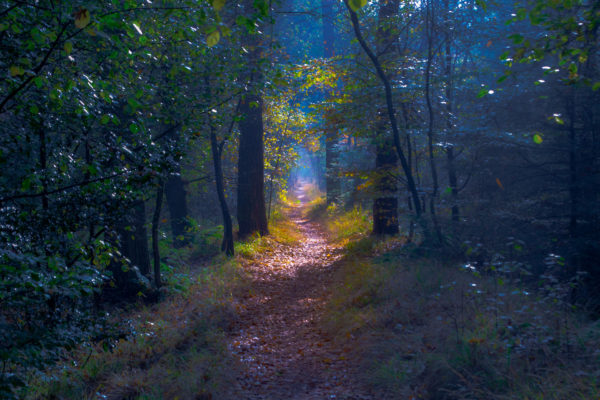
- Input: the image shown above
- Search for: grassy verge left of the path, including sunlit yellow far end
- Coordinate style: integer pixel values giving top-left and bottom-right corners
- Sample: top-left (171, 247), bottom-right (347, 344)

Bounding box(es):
top-left (24, 208), bottom-right (299, 400)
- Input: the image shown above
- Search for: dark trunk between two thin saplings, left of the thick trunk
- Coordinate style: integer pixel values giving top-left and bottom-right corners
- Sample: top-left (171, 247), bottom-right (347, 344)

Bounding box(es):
top-left (165, 168), bottom-right (190, 248)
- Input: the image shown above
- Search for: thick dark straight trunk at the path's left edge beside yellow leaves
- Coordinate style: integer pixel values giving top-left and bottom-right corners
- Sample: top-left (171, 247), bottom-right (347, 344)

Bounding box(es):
top-left (237, 93), bottom-right (269, 238)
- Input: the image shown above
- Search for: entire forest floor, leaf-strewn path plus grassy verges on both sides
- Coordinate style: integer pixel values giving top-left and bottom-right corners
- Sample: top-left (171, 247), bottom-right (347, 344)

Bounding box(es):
top-left (24, 185), bottom-right (600, 400)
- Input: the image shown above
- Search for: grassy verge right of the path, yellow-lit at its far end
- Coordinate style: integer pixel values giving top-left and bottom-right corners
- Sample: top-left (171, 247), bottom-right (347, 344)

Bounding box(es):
top-left (310, 203), bottom-right (600, 400)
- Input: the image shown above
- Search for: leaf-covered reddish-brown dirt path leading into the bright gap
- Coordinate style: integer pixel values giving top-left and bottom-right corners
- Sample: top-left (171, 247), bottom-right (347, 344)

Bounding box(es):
top-left (229, 187), bottom-right (372, 400)
